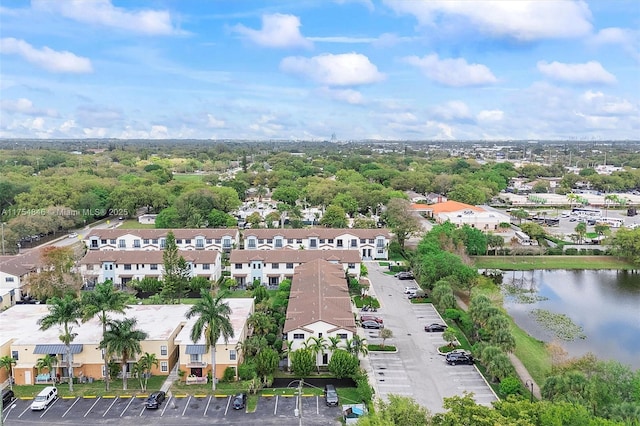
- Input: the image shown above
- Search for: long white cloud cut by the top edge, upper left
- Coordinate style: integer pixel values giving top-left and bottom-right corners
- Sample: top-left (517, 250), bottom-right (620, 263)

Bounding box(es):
top-left (31, 0), bottom-right (181, 35)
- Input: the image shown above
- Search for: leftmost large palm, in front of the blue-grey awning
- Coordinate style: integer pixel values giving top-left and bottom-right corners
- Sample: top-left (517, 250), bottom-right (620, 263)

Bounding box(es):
top-left (38, 294), bottom-right (82, 392)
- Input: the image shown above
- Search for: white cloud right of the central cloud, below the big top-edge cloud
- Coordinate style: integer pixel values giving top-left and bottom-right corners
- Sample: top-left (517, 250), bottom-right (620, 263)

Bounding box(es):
top-left (404, 54), bottom-right (498, 87)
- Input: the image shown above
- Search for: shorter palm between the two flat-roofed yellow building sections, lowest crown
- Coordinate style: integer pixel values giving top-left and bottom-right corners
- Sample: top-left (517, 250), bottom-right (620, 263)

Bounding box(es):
top-left (100, 318), bottom-right (147, 390)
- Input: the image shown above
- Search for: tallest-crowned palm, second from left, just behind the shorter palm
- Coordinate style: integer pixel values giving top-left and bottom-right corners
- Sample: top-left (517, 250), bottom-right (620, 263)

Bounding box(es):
top-left (82, 280), bottom-right (129, 390)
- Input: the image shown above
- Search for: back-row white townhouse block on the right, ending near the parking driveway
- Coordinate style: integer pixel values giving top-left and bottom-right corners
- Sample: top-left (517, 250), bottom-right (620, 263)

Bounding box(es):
top-left (242, 228), bottom-right (391, 260)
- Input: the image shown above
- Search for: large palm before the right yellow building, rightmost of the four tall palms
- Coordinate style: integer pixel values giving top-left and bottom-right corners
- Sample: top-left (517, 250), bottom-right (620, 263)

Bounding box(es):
top-left (186, 290), bottom-right (234, 391)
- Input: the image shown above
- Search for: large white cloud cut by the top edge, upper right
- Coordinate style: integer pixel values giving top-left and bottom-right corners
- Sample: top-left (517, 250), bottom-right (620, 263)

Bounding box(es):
top-left (385, 0), bottom-right (591, 41)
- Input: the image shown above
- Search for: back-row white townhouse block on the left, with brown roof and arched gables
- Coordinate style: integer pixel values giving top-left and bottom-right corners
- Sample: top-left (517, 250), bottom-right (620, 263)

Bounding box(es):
top-left (84, 228), bottom-right (240, 252)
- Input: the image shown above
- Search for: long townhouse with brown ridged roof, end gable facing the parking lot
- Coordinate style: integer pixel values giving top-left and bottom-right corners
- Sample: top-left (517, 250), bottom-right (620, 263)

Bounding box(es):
top-left (283, 259), bottom-right (357, 366)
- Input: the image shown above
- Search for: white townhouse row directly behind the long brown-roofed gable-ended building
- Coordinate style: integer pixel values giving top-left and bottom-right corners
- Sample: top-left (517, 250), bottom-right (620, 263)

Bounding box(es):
top-left (229, 249), bottom-right (362, 286)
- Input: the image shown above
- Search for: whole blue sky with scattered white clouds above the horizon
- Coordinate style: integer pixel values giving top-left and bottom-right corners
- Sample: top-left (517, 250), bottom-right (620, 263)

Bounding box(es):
top-left (0, 0), bottom-right (640, 140)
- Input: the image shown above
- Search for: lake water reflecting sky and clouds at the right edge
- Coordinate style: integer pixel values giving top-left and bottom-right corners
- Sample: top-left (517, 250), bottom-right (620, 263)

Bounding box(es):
top-left (503, 270), bottom-right (640, 370)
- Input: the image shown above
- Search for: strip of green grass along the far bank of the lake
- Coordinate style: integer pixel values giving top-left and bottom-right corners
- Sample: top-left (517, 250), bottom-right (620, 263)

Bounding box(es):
top-left (472, 256), bottom-right (640, 271)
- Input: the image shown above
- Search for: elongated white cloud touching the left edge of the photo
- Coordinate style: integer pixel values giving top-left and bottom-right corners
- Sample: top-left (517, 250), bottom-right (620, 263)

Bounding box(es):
top-left (0, 37), bottom-right (93, 73)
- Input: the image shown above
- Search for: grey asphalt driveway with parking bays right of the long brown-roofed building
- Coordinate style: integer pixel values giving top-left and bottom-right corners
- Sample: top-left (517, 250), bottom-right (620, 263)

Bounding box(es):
top-left (364, 262), bottom-right (497, 413)
